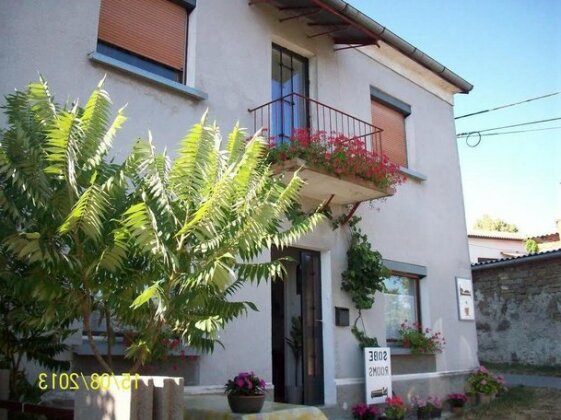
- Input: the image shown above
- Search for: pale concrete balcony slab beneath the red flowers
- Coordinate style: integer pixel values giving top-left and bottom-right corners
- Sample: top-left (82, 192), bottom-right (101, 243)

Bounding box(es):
top-left (273, 158), bottom-right (394, 205)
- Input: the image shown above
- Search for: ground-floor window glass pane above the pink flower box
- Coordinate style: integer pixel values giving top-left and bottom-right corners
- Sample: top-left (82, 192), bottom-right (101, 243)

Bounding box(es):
top-left (384, 276), bottom-right (419, 339)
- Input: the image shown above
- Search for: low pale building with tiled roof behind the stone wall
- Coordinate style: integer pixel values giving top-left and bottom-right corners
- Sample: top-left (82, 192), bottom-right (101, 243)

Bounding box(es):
top-left (468, 230), bottom-right (528, 264)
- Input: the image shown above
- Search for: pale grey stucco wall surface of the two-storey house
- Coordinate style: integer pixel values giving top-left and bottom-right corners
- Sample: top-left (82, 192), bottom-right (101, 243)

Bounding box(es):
top-left (0, 0), bottom-right (477, 401)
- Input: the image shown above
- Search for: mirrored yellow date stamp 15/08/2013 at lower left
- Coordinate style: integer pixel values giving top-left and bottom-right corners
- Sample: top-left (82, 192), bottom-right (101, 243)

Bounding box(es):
top-left (37, 372), bottom-right (140, 391)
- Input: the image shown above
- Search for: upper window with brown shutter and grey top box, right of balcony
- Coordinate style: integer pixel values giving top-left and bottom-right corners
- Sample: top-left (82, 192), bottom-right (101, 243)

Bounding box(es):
top-left (370, 87), bottom-right (411, 168)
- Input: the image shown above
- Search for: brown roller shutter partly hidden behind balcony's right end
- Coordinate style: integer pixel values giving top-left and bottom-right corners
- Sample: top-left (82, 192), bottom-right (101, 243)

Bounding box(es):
top-left (372, 100), bottom-right (407, 167)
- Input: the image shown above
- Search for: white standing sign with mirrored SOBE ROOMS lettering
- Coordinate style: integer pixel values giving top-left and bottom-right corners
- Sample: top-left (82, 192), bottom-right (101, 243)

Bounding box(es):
top-left (364, 347), bottom-right (392, 404)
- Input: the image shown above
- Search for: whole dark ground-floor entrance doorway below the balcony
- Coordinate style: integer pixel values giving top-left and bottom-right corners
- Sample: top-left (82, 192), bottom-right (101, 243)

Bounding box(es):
top-left (271, 248), bottom-right (324, 405)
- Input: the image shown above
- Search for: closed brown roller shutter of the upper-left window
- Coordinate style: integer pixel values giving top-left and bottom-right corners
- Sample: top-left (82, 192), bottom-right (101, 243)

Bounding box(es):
top-left (99, 0), bottom-right (187, 71)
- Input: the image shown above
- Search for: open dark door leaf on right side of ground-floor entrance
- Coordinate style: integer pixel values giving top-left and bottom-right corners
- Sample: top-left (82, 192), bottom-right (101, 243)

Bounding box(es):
top-left (300, 251), bottom-right (323, 405)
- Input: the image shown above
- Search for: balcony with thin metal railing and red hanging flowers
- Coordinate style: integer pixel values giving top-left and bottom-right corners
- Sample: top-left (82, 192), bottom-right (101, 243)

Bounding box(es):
top-left (249, 93), bottom-right (400, 205)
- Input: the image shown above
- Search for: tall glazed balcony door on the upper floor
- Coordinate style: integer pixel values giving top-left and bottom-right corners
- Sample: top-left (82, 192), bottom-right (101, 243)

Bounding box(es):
top-left (269, 44), bottom-right (309, 143)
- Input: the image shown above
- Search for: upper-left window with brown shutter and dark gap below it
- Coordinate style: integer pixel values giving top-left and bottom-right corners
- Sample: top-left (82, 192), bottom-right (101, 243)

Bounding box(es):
top-left (97, 0), bottom-right (194, 83)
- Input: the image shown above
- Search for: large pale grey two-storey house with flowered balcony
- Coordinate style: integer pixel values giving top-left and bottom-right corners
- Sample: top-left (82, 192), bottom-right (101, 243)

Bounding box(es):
top-left (0, 0), bottom-right (478, 406)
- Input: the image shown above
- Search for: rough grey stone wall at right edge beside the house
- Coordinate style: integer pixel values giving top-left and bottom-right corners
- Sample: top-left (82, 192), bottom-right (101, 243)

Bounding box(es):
top-left (472, 252), bottom-right (561, 365)
